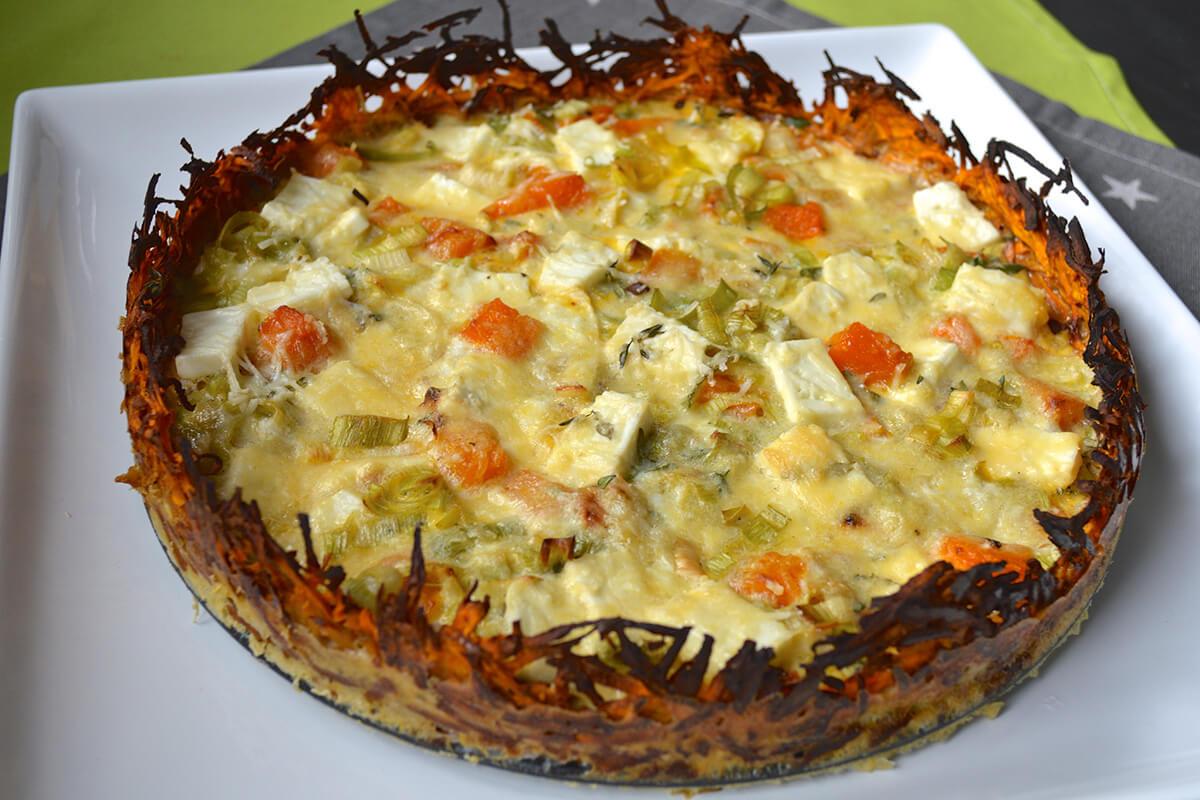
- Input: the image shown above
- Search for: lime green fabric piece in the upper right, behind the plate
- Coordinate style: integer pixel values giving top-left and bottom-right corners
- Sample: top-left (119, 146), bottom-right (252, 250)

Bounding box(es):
top-left (787, 0), bottom-right (1171, 145)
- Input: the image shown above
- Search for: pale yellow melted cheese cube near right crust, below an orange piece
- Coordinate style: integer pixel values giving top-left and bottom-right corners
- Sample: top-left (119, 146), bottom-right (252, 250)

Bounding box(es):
top-left (971, 426), bottom-right (1082, 492)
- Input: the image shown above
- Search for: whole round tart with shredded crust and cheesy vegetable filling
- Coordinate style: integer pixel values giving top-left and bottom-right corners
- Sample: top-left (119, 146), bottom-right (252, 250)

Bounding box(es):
top-left (122, 7), bottom-right (1142, 786)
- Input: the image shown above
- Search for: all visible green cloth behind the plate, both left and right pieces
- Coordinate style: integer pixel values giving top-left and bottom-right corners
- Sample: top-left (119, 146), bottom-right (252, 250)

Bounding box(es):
top-left (0, 0), bottom-right (1170, 173)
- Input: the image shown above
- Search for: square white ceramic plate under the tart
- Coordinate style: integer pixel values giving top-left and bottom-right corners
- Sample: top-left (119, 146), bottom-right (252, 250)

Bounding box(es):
top-left (0, 25), bottom-right (1200, 799)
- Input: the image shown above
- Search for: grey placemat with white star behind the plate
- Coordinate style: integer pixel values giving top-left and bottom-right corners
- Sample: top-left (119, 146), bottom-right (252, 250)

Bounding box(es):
top-left (0, 0), bottom-right (1200, 318)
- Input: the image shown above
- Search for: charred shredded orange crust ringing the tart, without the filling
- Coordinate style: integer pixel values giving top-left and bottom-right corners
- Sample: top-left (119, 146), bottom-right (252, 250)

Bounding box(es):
top-left (122, 3), bottom-right (1142, 786)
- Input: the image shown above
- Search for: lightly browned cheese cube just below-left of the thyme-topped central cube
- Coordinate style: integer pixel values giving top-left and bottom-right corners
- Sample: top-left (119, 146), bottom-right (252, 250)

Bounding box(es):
top-left (546, 391), bottom-right (648, 487)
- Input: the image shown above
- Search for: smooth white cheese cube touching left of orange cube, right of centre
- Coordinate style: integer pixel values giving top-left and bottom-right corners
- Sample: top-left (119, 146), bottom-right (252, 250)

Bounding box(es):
top-left (762, 339), bottom-right (863, 427)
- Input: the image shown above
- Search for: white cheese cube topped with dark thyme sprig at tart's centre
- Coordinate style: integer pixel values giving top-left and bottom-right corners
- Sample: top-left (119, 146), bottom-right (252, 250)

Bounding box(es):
top-left (605, 305), bottom-right (712, 407)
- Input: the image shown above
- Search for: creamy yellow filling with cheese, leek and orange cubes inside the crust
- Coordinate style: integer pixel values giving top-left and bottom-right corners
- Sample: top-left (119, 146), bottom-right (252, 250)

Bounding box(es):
top-left (174, 101), bottom-right (1099, 668)
